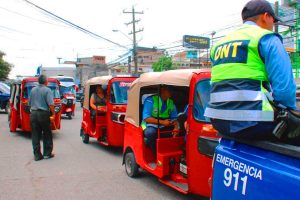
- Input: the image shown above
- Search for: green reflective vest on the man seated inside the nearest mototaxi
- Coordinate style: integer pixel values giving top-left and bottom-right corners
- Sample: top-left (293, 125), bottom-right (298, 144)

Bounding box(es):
top-left (141, 95), bottom-right (174, 130)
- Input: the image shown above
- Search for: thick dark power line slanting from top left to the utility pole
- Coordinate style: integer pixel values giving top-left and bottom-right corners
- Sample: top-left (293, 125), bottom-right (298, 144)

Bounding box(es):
top-left (23, 0), bottom-right (128, 49)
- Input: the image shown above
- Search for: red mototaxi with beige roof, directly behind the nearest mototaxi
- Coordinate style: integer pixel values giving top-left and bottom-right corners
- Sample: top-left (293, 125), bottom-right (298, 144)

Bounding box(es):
top-left (80, 76), bottom-right (136, 147)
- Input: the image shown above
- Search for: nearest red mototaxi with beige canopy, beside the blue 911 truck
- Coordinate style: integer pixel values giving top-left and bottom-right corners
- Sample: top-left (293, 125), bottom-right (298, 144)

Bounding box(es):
top-left (123, 69), bottom-right (218, 197)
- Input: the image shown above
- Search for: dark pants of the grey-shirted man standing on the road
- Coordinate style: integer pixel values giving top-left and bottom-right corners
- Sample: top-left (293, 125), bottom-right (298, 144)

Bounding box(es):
top-left (30, 110), bottom-right (53, 156)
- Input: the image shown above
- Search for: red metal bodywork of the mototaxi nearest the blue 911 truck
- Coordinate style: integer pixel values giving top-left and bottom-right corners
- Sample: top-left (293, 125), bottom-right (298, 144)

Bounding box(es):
top-left (123, 72), bottom-right (217, 197)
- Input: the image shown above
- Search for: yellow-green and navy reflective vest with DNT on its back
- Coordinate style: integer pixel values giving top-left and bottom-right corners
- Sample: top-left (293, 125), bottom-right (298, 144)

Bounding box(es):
top-left (204, 24), bottom-right (280, 121)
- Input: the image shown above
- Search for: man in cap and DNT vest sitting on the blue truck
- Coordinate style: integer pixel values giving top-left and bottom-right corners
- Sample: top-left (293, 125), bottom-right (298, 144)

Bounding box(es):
top-left (205, 0), bottom-right (296, 139)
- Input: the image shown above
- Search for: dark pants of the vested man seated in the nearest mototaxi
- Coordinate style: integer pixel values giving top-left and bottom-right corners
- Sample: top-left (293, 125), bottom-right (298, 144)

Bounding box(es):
top-left (144, 126), bottom-right (174, 153)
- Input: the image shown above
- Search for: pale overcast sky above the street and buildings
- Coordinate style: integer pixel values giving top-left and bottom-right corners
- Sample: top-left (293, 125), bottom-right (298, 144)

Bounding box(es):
top-left (0, 0), bottom-right (274, 78)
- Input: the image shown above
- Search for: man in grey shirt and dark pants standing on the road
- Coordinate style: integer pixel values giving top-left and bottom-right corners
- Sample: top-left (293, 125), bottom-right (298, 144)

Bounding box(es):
top-left (29, 75), bottom-right (55, 161)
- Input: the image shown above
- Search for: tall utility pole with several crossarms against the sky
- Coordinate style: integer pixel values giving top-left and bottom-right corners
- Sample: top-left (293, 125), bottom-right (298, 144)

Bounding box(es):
top-left (123, 6), bottom-right (144, 74)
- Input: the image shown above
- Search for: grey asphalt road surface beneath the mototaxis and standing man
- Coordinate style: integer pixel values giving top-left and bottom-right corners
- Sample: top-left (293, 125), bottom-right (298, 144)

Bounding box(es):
top-left (0, 104), bottom-right (204, 200)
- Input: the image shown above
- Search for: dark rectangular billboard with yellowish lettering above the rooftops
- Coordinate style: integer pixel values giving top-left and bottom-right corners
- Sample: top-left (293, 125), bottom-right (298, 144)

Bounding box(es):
top-left (183, 35), bottom-right (210, 49)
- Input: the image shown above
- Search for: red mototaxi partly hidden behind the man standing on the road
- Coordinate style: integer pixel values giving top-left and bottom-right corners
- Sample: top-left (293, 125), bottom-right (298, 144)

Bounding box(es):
top-left (8, 77), bottom-right (61, 132)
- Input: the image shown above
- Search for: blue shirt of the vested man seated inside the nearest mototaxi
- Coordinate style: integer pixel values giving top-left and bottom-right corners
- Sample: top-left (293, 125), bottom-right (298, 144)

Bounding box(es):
top-left (143, 96), bottom-right (177, 127)
